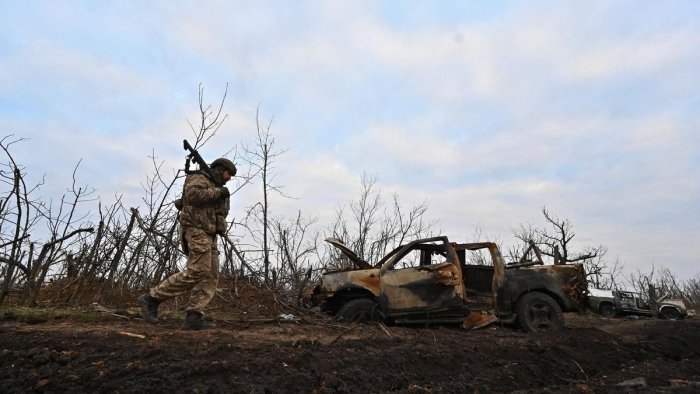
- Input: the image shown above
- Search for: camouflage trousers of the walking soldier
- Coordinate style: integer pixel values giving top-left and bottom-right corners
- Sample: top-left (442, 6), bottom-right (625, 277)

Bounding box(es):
top-left (149, 227), bottom-right (219, 313)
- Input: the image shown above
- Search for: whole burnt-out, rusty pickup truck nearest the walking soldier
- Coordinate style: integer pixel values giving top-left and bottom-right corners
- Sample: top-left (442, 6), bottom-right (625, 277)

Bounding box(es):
top-left (311, 236), bottom-right (587, 332)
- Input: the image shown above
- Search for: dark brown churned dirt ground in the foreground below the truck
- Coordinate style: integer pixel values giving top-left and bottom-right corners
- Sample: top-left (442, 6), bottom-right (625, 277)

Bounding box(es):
top-left (0, 304), bottom-right (700, 393)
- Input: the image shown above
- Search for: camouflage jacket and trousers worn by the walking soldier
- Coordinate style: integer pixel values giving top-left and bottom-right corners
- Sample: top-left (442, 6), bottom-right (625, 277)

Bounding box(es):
top-left (149, 172), bottom-right (229, 314)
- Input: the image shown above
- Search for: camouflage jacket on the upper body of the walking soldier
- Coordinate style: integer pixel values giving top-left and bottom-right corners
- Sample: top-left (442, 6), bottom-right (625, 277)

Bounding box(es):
top-left (180, 172), bottom-right (229, 235)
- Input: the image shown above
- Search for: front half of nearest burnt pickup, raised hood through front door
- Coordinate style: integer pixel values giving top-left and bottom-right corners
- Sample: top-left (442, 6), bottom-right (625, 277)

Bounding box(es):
top-left (312, 237), bottom-right (469, 323)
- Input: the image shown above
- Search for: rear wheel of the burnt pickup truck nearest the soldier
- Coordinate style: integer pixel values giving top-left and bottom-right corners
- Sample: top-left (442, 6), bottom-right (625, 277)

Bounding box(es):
top-left (515, 292), bottom-right (564, 332)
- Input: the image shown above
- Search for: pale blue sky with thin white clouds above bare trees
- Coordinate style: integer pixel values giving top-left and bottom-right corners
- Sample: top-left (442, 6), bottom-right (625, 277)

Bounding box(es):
top-left (0, 0), bottom-right (700, 279)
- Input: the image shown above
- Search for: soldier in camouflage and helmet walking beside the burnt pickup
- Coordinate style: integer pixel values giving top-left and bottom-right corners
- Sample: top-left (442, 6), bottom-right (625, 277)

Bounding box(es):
top-left (137, 158), bottom-right (236, 330)
